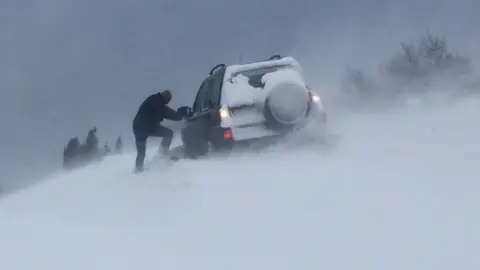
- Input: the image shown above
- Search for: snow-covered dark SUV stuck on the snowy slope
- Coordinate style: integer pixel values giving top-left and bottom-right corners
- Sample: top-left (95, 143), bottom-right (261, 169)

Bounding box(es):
top-left (182, 55), bottom-right (327, 157)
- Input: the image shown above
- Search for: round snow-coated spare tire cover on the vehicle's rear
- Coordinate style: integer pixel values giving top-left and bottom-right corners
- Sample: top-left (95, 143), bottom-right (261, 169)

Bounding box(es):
top-left (264, 82), bottom-right (310, 127)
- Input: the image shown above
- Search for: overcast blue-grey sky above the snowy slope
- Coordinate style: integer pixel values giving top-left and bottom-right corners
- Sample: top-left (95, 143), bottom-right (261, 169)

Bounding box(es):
top-left (0, 0), bottom-right (480, 190)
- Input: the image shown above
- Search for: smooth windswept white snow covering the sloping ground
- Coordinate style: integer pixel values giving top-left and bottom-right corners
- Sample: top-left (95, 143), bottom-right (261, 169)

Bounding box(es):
top-left (0, 96), bottom-right (480, 270)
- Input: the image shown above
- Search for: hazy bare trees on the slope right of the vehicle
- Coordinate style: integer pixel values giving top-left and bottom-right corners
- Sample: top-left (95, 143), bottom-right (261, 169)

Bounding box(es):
top-left (342, 31), bottom-right (473, 106)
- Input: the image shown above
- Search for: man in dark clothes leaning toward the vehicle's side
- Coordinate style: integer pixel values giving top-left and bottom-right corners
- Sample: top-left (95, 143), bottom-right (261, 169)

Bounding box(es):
top-left (133, 90), bottom-right (187, 172)
